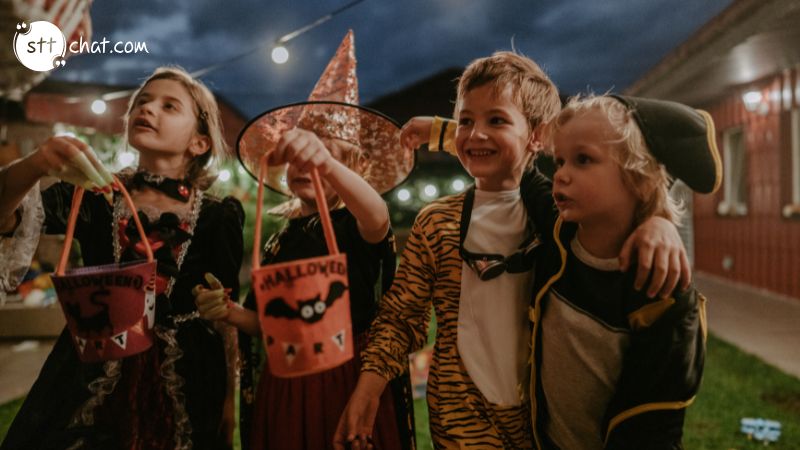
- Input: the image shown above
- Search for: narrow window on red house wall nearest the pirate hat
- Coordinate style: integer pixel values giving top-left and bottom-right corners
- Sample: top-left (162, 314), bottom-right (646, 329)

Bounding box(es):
top-left (717, 128), bottom-right (747, 216)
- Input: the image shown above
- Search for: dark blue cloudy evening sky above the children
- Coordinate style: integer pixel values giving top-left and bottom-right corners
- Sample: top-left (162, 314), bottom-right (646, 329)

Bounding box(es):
top-left (54, 0), bottom-right (732, 117)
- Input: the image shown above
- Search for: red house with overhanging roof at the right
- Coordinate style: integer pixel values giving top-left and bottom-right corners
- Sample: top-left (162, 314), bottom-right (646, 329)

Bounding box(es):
top-left (626, 0), bottom-right (800, 301)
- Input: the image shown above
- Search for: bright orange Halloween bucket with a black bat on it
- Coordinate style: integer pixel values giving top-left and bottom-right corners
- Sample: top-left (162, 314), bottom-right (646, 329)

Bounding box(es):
top-left (252, 153), bottom-right (353, 377)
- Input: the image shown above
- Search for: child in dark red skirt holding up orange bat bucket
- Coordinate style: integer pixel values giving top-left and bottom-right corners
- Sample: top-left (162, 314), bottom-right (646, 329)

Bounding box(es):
top-left (196, 128), bottom-right (412, 450)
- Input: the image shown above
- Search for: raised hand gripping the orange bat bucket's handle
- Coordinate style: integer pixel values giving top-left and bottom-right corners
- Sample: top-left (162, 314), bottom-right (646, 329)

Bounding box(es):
top-left (268, 128), bottom-right (335, 175)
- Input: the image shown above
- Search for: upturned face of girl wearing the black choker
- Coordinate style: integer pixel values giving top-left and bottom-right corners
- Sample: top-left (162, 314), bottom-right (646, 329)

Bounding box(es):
top-left (128, 79), bottom-right (210, 162)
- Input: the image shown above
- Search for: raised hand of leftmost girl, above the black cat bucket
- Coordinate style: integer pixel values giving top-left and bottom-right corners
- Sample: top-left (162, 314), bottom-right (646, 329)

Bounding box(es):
top-left (32, 136), bottom-right (114, 192)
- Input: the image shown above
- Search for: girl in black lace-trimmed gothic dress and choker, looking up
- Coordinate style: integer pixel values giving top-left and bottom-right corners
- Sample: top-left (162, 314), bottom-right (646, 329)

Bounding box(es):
top-left (0, 68), bottom-right (244, 450)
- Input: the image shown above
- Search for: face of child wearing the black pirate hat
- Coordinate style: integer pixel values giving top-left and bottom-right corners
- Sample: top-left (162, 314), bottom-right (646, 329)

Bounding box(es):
top-left (553, 111), bottom-right (637, 226)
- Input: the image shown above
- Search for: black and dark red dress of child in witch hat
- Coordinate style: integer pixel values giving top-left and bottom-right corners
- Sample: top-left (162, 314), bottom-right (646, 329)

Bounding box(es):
top-left (239, 209), bottom-right (414, 450)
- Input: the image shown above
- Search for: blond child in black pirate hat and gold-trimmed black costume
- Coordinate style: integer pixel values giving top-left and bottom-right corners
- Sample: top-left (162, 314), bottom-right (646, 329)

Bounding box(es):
top-left (531, 96), bottom-right (720, 450)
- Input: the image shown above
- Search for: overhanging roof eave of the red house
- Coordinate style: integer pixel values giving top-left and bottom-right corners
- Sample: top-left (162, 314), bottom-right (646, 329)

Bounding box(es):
top-left (625, 0), bottom-right (800, 105)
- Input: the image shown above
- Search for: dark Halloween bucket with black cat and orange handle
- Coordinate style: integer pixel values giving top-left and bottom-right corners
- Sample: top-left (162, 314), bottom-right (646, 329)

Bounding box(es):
top-left (53, 177), bottom-right (156, 362)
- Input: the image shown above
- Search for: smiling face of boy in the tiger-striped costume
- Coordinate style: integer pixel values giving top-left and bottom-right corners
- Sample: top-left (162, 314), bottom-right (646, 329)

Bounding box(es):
top-left (456, 84), bottom-right (536, 191)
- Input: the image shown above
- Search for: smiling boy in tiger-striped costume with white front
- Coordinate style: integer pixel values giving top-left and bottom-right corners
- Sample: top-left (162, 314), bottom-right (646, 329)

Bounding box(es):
top-left (334, 52), bottom-right (692, 448)
